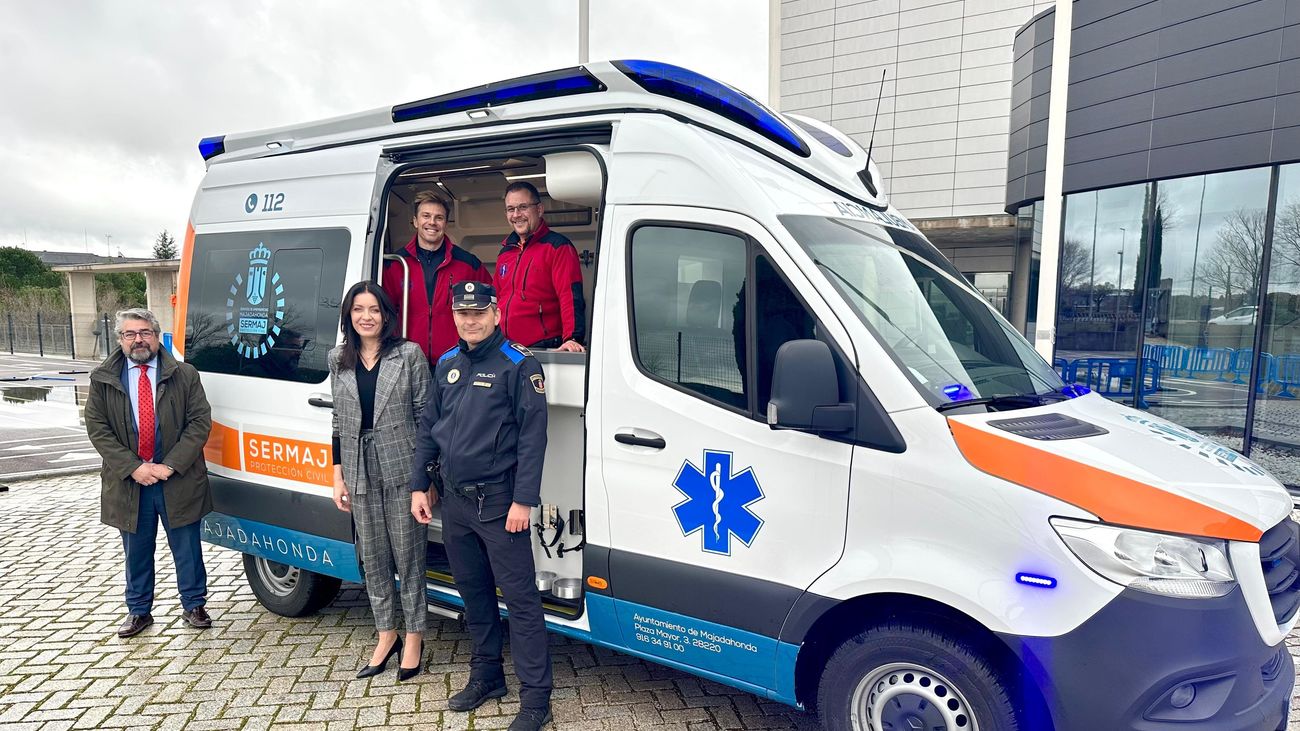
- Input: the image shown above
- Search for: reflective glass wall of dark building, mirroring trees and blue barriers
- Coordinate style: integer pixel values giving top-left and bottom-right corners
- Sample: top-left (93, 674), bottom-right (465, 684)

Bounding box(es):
top-left (1050, 165), bottom-right (1300, 486)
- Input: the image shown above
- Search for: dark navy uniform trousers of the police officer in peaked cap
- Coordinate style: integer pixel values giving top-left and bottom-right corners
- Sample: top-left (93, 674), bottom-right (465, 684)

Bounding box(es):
top-left (442, 490), bottom-right (551, 708)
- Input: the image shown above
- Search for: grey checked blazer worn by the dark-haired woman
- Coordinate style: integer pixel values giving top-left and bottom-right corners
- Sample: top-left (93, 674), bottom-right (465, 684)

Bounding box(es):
top-left (329, 341), bottom-right (430, 494)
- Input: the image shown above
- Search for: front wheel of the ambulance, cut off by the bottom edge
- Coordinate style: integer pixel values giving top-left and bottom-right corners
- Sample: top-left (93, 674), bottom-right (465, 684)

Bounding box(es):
top-left (818, 622), bottom-right (1022, 731)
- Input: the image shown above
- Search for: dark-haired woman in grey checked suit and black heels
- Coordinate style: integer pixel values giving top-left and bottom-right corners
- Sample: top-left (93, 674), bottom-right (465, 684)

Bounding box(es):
top-left (329, 281), bottom-right (429, 680)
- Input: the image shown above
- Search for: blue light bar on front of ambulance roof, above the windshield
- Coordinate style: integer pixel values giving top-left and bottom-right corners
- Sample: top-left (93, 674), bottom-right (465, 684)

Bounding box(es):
top-left (614, 61), bottom-right (810, 157)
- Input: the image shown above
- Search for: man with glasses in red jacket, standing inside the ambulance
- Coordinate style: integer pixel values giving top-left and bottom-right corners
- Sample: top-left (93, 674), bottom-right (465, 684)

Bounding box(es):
top-left (493, 181), bottom-right (586, 352)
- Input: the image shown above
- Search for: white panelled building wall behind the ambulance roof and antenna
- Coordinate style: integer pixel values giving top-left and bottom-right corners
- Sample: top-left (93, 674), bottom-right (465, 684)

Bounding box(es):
top-left (772, 0), bottom-right (1054, 219)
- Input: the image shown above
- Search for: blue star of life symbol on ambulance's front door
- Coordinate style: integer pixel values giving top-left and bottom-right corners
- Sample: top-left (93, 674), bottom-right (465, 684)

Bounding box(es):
top-left (672, 449), bottom-right (763, 555)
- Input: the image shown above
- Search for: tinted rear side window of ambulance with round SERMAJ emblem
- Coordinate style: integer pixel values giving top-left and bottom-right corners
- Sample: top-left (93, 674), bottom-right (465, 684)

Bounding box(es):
top-left (185, 229), bottom-right (351, 384)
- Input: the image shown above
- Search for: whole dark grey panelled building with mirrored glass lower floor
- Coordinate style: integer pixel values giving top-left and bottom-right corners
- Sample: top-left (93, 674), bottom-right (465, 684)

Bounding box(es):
top-left (1006, 0), bottom-right (1300, 496)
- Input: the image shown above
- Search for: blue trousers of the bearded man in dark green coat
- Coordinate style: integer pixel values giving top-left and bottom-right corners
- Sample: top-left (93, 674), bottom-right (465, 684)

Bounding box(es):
top-left (122, 483), bottom-right (208, 614)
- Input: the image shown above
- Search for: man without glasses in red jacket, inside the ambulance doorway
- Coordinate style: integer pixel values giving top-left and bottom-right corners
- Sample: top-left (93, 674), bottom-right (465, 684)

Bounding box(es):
top-left (384, 190), bottom-right (491, 360)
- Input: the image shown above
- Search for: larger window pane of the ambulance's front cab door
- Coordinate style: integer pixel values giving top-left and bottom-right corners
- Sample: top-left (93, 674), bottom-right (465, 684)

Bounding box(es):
top-left (631, 225), bottom-right (749, 411)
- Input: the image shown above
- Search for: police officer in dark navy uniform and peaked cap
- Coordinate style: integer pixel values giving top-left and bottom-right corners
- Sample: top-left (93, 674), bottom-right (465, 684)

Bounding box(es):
top-left (411, 282), bottom-right (551, 731)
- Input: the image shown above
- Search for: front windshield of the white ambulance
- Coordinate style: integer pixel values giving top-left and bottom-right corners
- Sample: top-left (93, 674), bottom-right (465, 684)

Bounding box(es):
top-left (780, 216), bottom-right (1065, 407)
